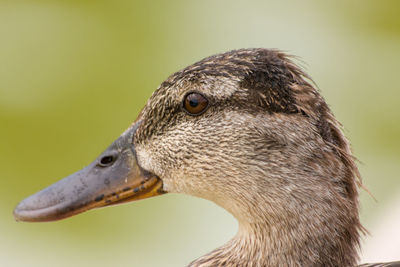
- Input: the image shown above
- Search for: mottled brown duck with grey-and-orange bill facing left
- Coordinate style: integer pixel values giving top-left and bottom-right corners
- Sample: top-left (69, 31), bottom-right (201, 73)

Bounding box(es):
top-left (14, 48), bottom-right (400, 267)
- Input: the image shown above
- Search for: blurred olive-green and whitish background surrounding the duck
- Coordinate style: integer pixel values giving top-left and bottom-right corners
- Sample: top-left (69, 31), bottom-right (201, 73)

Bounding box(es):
top-left (0, 0), bottom-right (400, 267)
